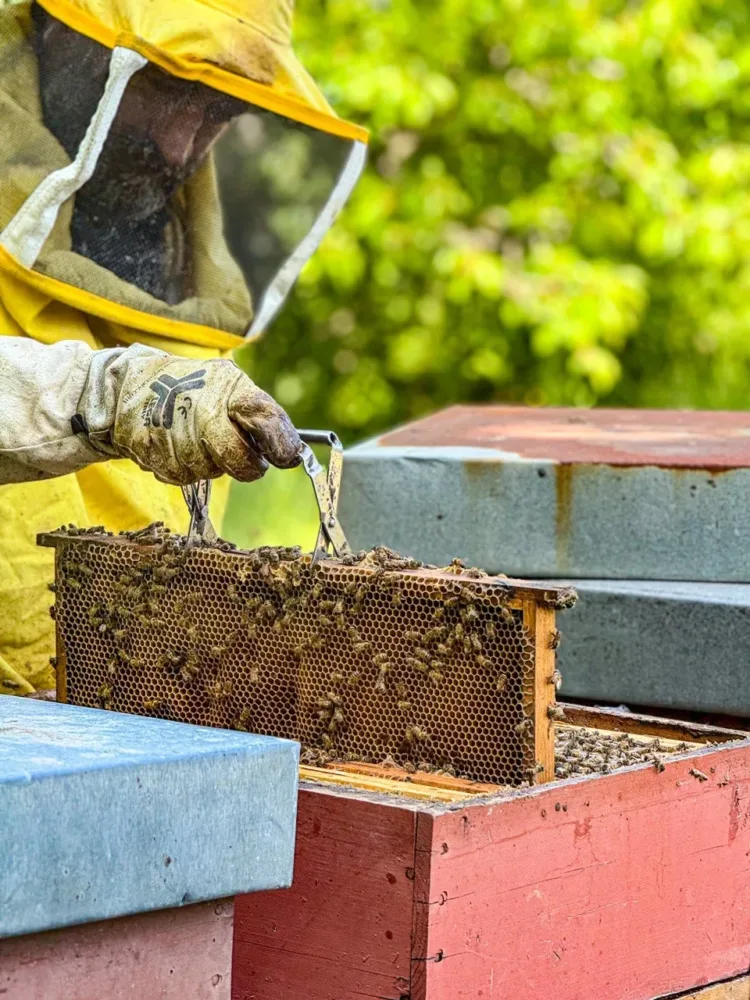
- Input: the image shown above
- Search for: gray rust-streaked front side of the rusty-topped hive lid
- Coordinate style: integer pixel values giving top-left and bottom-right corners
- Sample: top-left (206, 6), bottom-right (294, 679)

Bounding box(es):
top-left (340, 441), bottom-right (750, 583)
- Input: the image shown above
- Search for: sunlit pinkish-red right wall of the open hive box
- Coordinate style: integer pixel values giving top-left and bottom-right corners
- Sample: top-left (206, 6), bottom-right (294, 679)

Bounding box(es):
top-left (414, 744), bottom-right (750, 1000)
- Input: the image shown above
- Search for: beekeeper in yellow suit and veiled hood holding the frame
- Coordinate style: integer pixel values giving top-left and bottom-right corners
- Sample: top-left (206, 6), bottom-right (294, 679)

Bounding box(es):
top-left (0, 0), bottom-right (366, 694)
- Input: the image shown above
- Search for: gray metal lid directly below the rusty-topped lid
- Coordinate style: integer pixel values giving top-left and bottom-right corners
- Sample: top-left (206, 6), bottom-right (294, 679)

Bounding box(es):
top-left (558, 580), bottom-right (750, 717)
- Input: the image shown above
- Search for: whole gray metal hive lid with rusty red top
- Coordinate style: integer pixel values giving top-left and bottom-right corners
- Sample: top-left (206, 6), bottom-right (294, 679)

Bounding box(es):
top-left (341, 406), bottom-right (750, 583)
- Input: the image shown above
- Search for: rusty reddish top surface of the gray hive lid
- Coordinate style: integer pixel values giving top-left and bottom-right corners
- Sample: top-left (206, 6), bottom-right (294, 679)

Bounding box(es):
top-left (379, 406), bottom-right (750, 472)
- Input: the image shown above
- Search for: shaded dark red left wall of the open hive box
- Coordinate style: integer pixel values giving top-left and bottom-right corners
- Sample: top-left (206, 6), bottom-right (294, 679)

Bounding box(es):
top-left (232, 789), bottom-right (416, 1000)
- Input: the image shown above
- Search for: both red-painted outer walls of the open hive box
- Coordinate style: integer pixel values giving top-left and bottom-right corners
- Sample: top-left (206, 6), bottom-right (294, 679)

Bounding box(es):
top-left (233, 741), bottom-right (750, 1000)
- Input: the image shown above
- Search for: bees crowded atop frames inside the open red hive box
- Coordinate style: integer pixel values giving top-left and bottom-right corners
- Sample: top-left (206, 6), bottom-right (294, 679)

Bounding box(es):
top-left (555, 728), bottom-right (687, 778)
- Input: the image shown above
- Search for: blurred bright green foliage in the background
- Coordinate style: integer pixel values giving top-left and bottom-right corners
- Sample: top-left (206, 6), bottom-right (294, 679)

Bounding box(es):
top-left (236, 0), bottom-right (750, 432)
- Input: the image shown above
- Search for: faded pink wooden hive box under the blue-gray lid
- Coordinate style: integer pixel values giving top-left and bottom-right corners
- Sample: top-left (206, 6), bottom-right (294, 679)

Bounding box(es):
top-left (0, 900), bottom-right (232, 1000)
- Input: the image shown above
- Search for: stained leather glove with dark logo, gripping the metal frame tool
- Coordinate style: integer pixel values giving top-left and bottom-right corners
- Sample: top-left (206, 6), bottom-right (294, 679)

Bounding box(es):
top-left (89, 355), bottom-right (302, 486)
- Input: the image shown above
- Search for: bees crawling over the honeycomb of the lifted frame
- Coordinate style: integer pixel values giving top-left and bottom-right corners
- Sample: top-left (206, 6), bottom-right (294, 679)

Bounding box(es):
top-left (54, 522), bottom-right (548, 774)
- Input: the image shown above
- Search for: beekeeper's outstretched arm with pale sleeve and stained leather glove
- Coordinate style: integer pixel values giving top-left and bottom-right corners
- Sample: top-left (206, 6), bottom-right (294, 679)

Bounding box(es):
top-left (0, 337), bottom-right (301, 485)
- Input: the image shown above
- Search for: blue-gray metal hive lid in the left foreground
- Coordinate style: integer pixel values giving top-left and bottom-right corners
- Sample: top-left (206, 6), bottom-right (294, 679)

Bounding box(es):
top-left (0, 697), bottom-right (299, 937)
